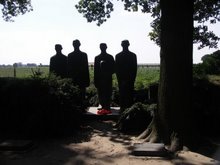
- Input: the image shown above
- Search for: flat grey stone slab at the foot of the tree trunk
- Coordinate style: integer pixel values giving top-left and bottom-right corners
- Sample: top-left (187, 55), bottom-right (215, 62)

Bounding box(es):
top-left (131, 143), bottom-right (167, 157)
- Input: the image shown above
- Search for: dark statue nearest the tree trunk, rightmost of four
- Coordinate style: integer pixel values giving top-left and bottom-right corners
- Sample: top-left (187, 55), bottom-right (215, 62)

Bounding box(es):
top-left (115, 40), bottom-right (137, 111)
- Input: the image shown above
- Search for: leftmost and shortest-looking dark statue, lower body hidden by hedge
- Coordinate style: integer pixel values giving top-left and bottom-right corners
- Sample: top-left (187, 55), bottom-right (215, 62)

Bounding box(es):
top-left (49, 44), bottom-right (67, 78)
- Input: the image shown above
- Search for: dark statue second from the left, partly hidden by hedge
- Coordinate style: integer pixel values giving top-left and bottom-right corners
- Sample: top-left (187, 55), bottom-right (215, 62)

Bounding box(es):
top-left (67, 40), bottom-right (90, 99)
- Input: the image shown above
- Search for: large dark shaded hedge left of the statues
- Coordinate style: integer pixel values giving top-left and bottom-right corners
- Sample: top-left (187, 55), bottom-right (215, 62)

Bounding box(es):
top-left (0, 77), bottom-right (81, 137)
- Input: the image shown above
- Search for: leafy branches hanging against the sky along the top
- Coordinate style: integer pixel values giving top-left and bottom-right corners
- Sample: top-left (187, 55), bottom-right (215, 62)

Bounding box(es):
top-left (0, 0), bottom-right (220, 49)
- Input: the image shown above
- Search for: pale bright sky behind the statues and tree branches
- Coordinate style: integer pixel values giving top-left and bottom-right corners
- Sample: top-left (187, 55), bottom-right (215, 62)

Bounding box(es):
top-left (0, 0), bottom-right (220, 65)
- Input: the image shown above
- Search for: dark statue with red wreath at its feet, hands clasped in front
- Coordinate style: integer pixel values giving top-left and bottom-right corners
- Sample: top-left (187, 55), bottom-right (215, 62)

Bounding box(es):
top-left (94, 43), bottom-right (115, 114)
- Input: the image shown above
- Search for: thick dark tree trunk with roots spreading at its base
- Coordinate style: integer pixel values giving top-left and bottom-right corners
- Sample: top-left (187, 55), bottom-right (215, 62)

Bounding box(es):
top-left (156, 0), bottom-right (193, 150)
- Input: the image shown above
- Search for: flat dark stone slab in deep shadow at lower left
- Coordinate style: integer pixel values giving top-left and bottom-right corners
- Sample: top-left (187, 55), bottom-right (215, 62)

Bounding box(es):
top-left (0, 140), bottom-right (33, 151)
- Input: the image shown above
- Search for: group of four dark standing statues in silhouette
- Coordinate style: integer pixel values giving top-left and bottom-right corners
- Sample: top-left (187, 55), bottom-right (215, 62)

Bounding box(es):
top-left (49, 40), bottom-right (137, 115)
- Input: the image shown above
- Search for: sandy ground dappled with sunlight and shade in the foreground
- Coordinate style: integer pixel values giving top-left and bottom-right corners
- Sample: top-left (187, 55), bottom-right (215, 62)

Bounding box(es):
top-left (0, 120), bottom-right (220, 165)
